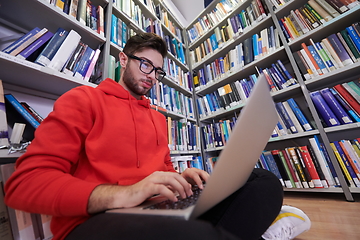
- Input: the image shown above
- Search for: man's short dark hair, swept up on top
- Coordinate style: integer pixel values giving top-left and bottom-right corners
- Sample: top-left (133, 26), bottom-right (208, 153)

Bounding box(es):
top-left (123, 33), bottom-right (167, 58)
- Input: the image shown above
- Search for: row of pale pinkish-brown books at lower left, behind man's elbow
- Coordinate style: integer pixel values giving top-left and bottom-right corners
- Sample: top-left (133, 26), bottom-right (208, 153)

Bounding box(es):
top-left (0, 163), bottom-right (53, 240)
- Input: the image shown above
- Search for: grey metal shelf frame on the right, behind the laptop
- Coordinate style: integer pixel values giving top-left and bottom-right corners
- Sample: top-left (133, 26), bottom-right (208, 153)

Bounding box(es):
top-left (186, 0), bottom-right (360, 201)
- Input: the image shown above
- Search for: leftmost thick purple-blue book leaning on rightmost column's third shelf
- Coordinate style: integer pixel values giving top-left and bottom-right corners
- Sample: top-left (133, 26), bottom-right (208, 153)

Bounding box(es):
top-left (310, 91), bottom-right (340, 127)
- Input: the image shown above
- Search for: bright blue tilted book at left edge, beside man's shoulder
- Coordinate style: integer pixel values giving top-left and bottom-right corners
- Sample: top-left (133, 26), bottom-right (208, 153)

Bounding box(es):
top-left (4, 93), bottom-right (40, 131)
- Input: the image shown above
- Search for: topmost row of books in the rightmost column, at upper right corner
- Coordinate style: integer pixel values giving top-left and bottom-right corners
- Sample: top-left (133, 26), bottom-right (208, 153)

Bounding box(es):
top-left (279, 0), bottom-right (360, 41)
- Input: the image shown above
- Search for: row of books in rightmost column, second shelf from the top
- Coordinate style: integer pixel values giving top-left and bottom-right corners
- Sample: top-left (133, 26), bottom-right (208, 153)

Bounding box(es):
top-left (293, 22), bottom-right (360, 80)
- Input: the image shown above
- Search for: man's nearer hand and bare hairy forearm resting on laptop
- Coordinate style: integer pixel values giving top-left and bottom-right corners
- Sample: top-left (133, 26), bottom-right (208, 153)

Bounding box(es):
top-left (88, 170), bottom-right (194, 214)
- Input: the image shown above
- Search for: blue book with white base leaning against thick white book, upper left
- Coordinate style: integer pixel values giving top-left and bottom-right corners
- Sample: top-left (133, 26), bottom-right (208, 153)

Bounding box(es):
top-left (35, 28), bottom-right (69, 67)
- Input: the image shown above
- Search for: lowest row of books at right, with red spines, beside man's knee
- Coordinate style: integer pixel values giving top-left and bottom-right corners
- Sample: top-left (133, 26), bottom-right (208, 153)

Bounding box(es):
top-left (257, 136), bottom-right (360, 188)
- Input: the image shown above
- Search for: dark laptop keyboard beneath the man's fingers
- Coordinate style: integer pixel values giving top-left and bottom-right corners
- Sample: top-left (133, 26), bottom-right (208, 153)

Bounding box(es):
top-left (144, 187), bottom-right (202, 209)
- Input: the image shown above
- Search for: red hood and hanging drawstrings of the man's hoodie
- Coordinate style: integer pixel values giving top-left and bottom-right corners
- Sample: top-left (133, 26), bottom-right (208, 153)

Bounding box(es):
top-left (97, 78), bottom-right (159, 167)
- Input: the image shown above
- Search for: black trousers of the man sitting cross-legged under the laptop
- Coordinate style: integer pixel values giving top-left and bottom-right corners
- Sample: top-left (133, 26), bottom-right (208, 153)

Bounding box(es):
top-left (65, 169), bottom-right (283, 240)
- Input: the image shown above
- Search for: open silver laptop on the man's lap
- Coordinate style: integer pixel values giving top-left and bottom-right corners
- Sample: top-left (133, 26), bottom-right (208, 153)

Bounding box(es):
top-left (107, 74), bottom-right (278, 220)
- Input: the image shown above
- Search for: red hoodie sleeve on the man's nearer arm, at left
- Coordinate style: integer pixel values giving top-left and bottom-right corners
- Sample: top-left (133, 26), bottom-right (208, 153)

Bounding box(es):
top-left (5, 87), bottom-right (98, 216)
